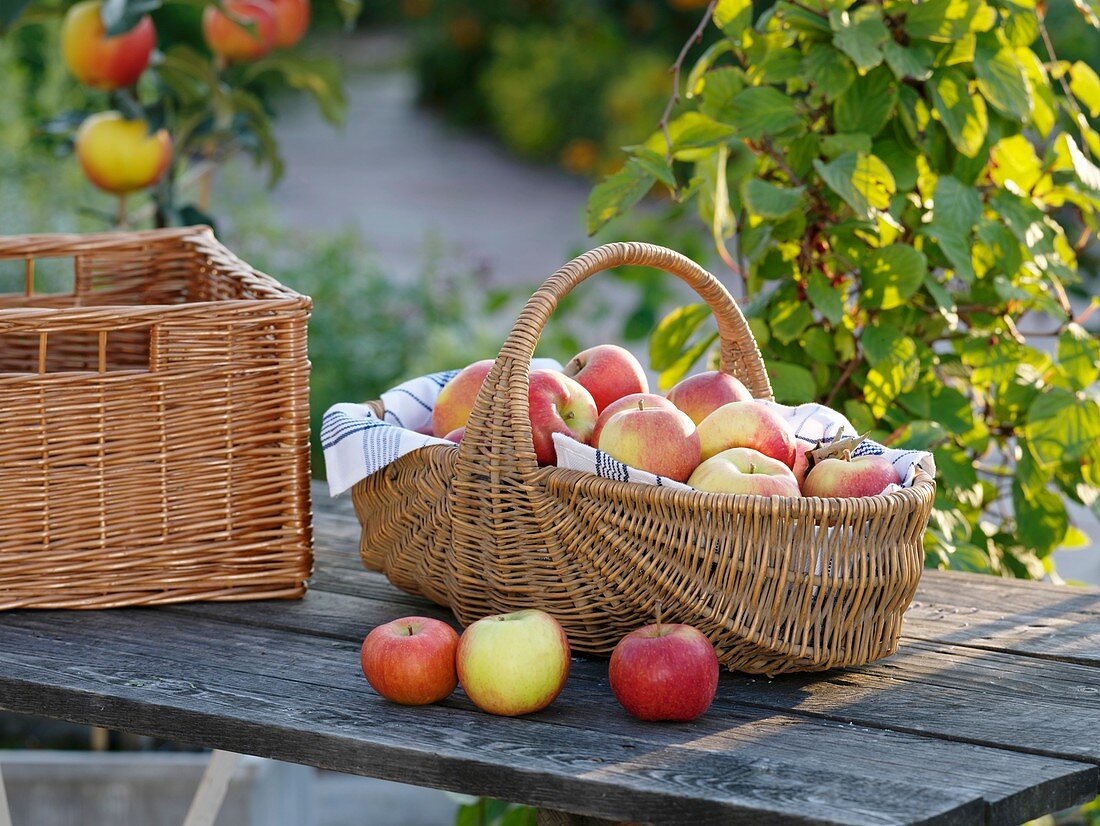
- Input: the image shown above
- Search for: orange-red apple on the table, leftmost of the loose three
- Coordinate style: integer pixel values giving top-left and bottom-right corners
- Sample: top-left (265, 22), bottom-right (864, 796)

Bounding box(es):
top-left (360, 617), bottom-right (459, 705)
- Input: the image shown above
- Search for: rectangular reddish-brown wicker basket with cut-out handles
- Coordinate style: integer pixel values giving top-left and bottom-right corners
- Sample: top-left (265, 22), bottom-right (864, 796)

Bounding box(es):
top-left (0, 227), bottom-right (311, 608)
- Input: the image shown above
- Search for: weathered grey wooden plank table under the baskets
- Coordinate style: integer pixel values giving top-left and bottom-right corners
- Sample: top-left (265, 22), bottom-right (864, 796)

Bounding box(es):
top-left (0, 494), bottom-right (1100, 824)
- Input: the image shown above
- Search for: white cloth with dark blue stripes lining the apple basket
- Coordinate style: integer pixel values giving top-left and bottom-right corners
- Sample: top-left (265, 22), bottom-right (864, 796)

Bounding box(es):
top-left (321, 359), bottom-right (936, 496)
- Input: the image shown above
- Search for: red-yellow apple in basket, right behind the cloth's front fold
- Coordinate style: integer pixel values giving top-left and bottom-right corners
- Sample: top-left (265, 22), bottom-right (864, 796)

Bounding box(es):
top-left (596, 407), bottom-right (700, 482)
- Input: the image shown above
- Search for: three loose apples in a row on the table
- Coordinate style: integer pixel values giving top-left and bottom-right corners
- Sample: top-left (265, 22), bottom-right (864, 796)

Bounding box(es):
top-left (360, 609), bottom-right (718, 720)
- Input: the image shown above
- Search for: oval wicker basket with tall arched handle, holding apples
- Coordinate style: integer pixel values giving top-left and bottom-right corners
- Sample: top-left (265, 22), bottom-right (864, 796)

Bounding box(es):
top-left (353, 243), bottom-right (935, 674)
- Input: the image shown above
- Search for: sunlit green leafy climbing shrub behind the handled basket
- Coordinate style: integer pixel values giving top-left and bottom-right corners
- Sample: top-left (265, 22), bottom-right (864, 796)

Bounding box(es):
top-left (589, 0), bottom-right (1100, 576)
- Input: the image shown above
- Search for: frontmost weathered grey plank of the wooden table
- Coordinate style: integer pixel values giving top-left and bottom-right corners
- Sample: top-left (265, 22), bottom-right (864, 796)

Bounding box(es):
top-left (0, 610), bottom-right (1001, 824)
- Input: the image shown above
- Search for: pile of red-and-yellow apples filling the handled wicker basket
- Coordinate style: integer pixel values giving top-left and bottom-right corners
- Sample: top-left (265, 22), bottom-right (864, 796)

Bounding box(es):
top-left (432, 344), bottom-right (899, 497)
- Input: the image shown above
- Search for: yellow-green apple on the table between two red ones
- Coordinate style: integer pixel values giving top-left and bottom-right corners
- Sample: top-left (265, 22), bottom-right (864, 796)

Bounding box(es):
top-left (458, 608), bottom-right (569, 717)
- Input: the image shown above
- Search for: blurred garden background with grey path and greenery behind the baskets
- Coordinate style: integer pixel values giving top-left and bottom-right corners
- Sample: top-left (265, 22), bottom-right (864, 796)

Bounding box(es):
top-left (0, 0), bottom-right (1100, 824)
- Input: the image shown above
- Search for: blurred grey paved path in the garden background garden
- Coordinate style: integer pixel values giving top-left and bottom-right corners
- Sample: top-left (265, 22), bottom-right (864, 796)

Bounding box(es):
top-left (259, 43), bottom-right (1100, 584)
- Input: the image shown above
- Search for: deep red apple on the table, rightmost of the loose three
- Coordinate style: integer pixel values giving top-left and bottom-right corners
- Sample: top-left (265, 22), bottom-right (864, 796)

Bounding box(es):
top-left (608, 623), bottom-right (718, 720)
